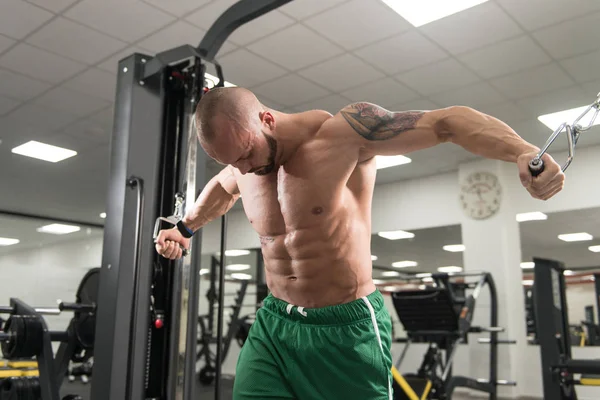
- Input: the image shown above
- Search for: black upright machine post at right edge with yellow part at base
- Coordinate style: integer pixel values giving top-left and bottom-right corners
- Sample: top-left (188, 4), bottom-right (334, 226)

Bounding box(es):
top-left (533, 258), bottom-right (600, 400)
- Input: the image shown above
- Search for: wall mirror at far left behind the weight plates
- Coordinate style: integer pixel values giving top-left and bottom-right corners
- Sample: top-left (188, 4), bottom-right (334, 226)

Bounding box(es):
top-left (0, 213), bottom-right (104, 330)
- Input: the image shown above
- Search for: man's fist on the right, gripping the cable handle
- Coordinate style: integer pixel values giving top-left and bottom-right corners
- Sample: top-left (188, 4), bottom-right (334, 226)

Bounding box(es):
top-left (517, 152), bottom-right (565, 200)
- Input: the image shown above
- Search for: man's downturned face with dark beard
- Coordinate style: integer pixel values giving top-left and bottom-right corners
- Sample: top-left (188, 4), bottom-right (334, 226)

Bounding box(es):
top-left (203, 118), bottom-right (277, 176)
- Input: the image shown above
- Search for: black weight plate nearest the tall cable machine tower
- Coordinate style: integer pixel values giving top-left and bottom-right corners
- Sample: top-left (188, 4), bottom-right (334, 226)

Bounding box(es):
top-left (73, 268), bottom-right (100, 349)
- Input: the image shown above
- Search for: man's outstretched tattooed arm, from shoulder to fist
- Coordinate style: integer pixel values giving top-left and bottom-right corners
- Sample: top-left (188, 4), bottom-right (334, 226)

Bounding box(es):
top-left (328, 102), bottom-right (564, 200)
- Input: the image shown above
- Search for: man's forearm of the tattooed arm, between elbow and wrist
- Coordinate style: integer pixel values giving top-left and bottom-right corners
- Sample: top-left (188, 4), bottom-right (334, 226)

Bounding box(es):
top-left (439, 106), bottom-right (539, 162)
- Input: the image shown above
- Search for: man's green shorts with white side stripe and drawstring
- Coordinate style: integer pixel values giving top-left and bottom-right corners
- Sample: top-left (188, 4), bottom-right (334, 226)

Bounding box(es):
top-left (233, 290), bottom-right (392, 400)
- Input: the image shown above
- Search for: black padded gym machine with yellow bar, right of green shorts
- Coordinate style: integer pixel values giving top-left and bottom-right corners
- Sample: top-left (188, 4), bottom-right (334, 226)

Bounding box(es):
top-left (392, 272), bottom-right (516, 400)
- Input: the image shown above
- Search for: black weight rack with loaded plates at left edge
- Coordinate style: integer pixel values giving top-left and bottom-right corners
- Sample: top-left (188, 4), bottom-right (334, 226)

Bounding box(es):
top-left (0, 268), bottom-right (100, 400)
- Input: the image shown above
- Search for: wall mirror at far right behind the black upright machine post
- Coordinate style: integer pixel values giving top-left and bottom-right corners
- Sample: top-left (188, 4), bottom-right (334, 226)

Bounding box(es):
top-left (517, 208), bottom-right (600, 346)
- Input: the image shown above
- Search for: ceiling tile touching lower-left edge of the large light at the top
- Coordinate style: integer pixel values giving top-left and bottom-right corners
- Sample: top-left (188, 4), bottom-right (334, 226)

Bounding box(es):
top-left (305, 0), bottom-right (411, 50)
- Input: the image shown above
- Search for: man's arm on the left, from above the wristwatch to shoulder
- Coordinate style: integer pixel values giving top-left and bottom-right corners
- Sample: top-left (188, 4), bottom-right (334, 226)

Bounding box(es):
top-left (182, 165), bottom-right (240, 232)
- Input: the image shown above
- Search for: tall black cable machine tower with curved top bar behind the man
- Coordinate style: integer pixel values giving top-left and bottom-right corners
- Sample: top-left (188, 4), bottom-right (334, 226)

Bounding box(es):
top-left (91, 0), bottom-right (291, 400)
